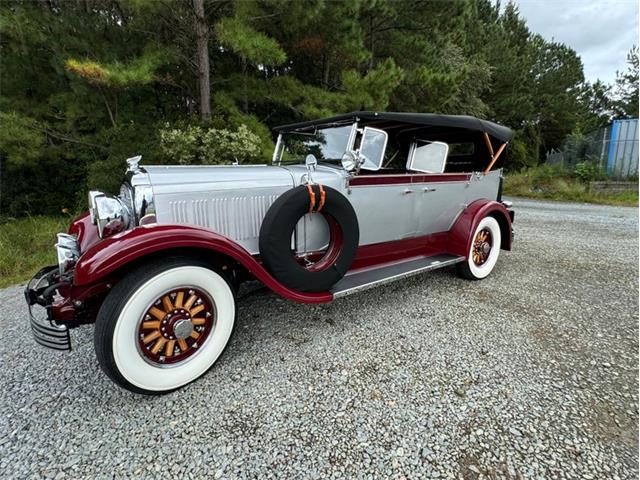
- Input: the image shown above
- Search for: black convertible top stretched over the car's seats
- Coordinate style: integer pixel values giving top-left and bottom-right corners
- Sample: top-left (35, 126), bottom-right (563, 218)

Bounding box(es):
top-left (275, 112), bottom-right (513, 142)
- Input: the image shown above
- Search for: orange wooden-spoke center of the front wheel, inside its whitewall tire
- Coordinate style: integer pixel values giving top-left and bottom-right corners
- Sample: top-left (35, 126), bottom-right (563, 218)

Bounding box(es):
top-left (138, 287), bottom-right (216, 366)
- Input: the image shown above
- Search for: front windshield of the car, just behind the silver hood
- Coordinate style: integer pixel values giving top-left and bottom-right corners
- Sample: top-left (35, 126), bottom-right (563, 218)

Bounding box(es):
top-left (276, 125), bottom-right (352, 164)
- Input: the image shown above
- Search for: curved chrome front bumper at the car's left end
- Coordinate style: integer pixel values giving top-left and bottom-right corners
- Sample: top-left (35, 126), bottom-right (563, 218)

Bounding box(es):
top-left (24, 266), bottom-right (71, 350)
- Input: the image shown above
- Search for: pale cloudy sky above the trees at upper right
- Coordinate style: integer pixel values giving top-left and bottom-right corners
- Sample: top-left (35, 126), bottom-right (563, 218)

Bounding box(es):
top-left (503, 0), bottom-right (639, 83)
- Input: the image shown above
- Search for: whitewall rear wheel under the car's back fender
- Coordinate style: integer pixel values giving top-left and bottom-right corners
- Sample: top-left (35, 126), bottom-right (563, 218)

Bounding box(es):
top-left (456, 217), bottom-right (501, 280)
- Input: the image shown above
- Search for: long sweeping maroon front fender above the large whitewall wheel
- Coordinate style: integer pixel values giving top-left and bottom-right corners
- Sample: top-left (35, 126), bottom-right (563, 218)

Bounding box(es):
top-left (74, 224), bottom-right (333, 303)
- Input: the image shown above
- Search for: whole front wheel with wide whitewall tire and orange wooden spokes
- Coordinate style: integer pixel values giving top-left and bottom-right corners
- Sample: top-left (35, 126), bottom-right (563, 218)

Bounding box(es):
top-left (94, 258), bottom-right (236, 394)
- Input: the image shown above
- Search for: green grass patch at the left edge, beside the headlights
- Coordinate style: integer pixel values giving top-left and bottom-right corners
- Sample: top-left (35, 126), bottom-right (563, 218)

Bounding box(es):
top-left (0, 216), bottom-right (71, 288)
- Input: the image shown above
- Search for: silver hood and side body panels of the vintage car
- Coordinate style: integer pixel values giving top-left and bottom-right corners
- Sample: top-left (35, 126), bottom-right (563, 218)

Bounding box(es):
top-left (139, 164), bottom-right (501, 254)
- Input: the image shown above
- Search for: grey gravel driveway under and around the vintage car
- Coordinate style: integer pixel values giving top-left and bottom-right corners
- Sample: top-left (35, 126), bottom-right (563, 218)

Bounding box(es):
top-left (0, 200), bottom-right (638, 479)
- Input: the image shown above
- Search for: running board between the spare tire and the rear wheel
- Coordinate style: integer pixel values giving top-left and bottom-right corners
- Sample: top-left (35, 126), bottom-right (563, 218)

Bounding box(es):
top-left (330, 253), bottom-right (464, 298)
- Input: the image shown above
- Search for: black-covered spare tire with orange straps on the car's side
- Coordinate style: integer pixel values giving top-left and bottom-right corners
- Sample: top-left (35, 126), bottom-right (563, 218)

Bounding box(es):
top-left (259, 185), bottom-right (360, 292)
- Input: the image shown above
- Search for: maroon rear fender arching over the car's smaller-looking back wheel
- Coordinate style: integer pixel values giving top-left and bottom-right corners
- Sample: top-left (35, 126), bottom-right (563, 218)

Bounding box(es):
top-left (448, 200), bottom-right (511, 258)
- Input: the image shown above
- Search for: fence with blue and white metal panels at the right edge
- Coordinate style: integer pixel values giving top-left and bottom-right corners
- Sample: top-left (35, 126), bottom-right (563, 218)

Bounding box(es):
top-left (546, 118), bottom-right (639, 179)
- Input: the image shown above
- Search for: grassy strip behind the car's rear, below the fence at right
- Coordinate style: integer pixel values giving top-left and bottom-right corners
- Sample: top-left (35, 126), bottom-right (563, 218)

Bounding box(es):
top-left (504, 165), bottom-right (638, 207)
